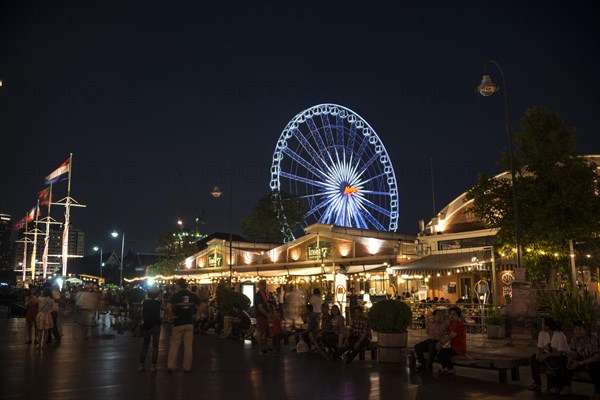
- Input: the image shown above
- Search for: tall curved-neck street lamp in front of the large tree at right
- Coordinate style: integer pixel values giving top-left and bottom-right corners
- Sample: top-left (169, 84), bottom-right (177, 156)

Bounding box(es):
top-left (475, 60), bottom-right (522, 284)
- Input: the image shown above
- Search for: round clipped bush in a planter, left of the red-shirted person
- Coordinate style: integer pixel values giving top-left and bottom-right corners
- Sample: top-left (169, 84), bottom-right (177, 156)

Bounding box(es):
top-left (367, 300), bottom-right (412, 362)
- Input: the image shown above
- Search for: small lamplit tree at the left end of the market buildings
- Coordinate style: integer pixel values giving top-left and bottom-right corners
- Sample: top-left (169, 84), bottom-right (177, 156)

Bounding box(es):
top-left (148, 231), bottom-right (198, 276)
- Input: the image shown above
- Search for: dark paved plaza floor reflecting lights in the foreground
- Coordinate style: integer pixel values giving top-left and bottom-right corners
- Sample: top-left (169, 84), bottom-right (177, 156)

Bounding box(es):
top-left (0, 314), bottom-right (593, 400)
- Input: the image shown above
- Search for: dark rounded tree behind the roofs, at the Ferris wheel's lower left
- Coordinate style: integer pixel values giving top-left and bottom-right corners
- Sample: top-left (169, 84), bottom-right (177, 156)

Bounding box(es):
top-left (242, 193), bottom-right (306, 243)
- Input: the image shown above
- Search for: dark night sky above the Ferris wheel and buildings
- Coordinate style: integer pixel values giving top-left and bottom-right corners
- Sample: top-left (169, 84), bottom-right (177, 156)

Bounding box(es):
top-left (0, 0), bottom-right (600, 251)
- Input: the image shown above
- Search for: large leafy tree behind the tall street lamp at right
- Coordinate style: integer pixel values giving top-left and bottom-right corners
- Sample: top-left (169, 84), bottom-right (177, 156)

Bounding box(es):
top-left (466, 107), bottom-right (600, 278)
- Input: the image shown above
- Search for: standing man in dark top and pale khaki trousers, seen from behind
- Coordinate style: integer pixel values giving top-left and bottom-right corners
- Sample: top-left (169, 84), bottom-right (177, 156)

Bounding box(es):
top-left (167, 278), bottom-right (200, 373)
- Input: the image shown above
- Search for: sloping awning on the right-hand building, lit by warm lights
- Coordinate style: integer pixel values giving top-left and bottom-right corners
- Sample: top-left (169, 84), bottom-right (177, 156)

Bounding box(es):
top-left (392, 249), bottom-right (499, 275)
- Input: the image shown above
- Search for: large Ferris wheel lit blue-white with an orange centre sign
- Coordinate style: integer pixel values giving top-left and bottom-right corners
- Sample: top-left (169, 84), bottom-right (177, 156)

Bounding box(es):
top-left (270, 104), bottom-right (398, 240)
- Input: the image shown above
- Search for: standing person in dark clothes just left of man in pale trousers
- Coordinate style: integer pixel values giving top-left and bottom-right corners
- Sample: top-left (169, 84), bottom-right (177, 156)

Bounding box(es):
top-left (138, 287), bottom-right (163, 372)
